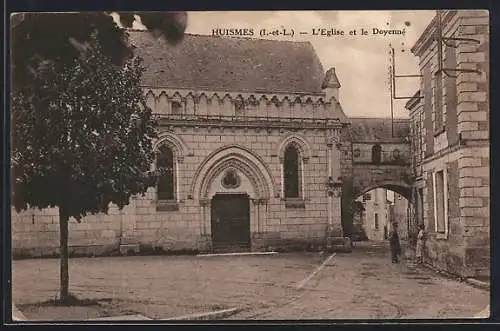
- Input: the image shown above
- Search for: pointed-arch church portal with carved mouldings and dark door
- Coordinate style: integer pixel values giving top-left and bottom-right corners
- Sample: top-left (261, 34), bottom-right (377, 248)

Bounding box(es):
top-left (190, 145), bottom-right (275, 252)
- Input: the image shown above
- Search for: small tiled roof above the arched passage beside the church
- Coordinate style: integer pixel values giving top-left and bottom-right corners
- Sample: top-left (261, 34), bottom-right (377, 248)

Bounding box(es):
top-left (349, 117), bottom-right (410, 142)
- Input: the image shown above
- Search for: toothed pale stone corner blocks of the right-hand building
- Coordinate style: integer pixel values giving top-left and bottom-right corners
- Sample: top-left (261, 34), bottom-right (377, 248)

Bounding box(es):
top-left (457, 11), bottom-right (490, 276)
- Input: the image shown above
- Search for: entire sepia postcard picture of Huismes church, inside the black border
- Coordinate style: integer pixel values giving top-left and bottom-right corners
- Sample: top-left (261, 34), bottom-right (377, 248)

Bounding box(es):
top-left (9, 9), bottom-right (491, 323)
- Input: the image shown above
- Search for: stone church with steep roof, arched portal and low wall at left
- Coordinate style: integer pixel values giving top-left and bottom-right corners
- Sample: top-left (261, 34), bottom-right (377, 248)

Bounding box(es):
top-left (12, 30), bottom-right (352, 256)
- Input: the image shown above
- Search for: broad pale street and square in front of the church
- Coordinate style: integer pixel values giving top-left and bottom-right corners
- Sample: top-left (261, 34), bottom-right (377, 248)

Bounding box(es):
top-left (13, 243), bottom-right (489, 320)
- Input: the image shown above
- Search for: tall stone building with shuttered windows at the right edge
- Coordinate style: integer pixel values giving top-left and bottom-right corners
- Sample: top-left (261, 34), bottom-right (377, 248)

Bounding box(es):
top-left (406, 10), bottom-right (490, 277)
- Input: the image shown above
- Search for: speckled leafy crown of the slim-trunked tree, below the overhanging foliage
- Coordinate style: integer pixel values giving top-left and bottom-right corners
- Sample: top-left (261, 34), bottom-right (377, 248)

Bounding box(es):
top-left (12, 39), bottom-right (155, 219)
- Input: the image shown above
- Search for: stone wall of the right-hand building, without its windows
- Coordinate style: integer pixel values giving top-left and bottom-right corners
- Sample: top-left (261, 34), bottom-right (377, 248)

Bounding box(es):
top-left (412, 10), bottom-right (490, 277)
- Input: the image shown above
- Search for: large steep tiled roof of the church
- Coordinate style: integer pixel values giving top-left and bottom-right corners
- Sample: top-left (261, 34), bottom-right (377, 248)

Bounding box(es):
top-left (128, 30), bottom-right (324, 94)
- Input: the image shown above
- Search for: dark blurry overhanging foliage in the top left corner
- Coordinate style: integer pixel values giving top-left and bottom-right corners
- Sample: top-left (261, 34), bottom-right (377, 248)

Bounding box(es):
top-left (11, 12), bottom-right (187, 89)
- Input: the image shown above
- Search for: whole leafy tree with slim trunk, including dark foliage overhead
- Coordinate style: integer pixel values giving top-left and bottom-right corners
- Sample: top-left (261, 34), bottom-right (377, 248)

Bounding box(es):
top-left (11, 13), bottom-right (185, 302)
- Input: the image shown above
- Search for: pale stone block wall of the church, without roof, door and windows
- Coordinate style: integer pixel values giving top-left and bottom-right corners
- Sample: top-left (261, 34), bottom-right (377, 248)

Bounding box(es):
top-left (12, 91), bottom-right (352, 256)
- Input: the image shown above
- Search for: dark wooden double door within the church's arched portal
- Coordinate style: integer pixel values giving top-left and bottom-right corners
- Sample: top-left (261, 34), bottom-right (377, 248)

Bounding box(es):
top-left (210, 193), bottom-right (250, 252)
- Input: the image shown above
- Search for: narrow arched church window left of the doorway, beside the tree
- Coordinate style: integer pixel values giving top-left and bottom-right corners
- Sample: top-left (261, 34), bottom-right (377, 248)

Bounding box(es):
top-left (156, 145), bottom-right (175, 200)
